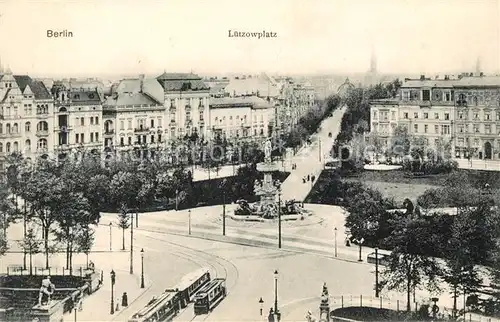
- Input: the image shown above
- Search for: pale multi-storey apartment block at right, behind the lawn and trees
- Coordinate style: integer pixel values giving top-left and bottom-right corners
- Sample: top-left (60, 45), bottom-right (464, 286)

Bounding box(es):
top-left (370, 74), bottom-right (500, 159)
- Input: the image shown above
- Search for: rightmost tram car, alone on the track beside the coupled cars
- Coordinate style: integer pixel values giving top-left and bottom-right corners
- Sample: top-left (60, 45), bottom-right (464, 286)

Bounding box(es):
top-left (194, 278), bottom-right (226, 315)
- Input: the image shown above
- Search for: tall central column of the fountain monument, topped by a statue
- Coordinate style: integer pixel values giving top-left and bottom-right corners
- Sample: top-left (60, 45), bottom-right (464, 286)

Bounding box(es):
top-left (254, 140), bottom-right (279, 218)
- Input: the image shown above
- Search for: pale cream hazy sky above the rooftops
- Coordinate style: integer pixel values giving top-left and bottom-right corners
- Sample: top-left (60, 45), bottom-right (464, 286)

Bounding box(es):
top-left (0, 0), bottom-right (500, 76)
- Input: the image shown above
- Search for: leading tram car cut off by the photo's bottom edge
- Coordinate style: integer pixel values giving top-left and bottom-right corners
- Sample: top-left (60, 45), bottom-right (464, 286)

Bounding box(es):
top-left (129, 291), bottom-right (180, 322)
